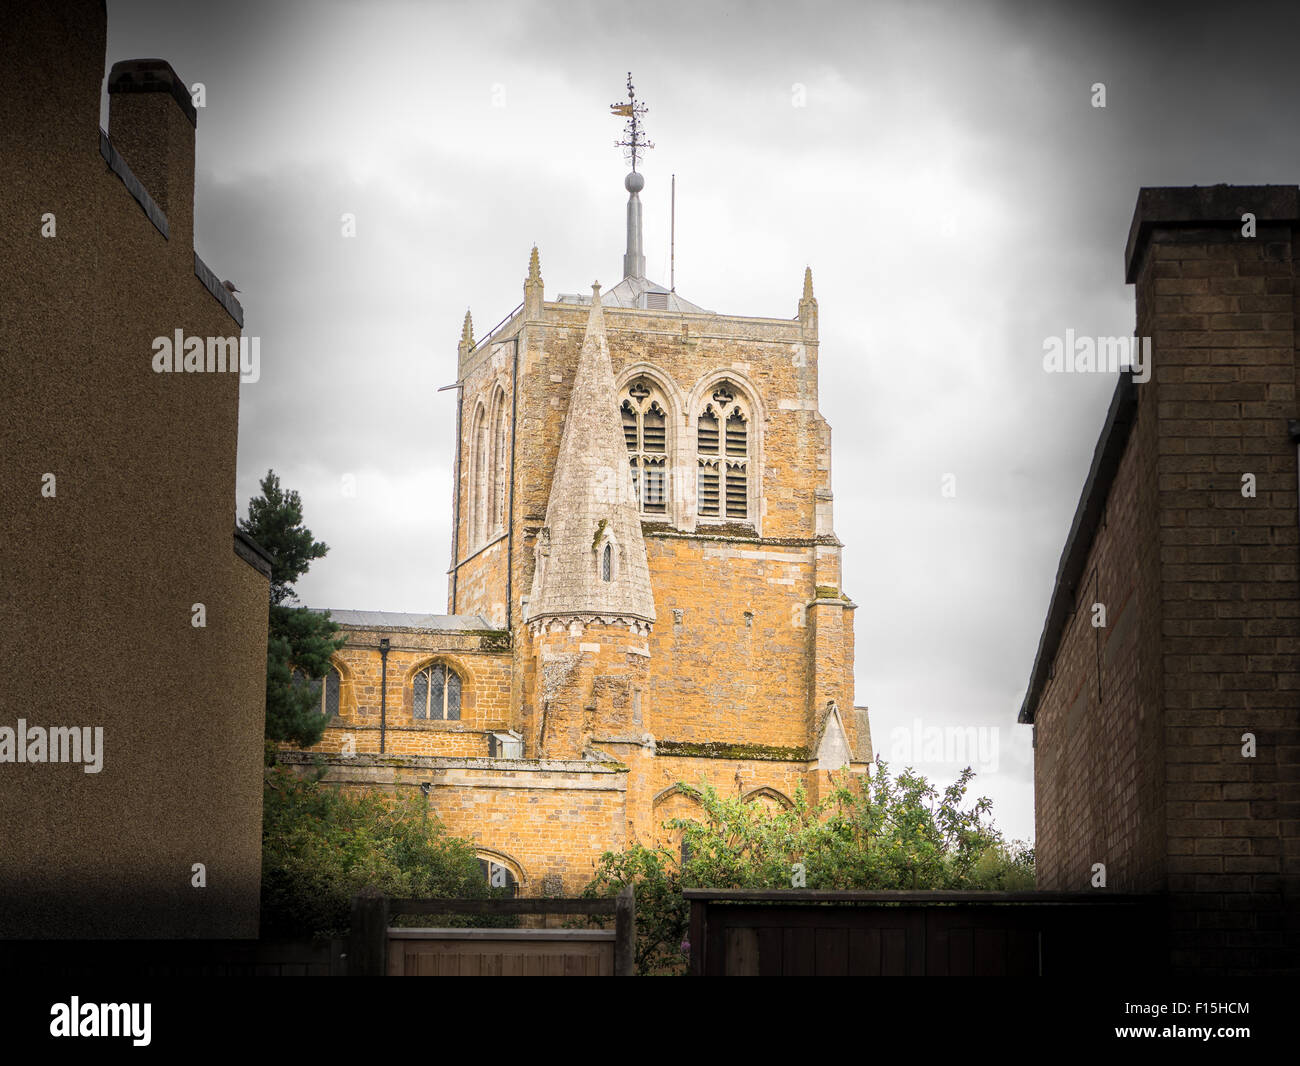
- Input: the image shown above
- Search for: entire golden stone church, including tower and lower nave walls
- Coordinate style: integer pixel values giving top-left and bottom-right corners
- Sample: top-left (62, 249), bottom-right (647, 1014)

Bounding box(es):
top-left (281, 89), bottom-right (871, 894)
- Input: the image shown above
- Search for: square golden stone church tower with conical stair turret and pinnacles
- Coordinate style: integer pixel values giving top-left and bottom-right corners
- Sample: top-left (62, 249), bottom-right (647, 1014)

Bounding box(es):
top-left (450, 112), bottom-right (870, 795)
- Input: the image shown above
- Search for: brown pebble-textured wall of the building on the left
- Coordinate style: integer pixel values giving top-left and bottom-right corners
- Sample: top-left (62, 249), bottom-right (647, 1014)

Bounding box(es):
top-left (0, 0), bottom-right (267, 937)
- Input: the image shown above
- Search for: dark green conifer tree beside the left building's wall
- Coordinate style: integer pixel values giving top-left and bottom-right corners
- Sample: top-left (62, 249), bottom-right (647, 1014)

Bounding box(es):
top-left (239, 471), bottom-right (345, 743)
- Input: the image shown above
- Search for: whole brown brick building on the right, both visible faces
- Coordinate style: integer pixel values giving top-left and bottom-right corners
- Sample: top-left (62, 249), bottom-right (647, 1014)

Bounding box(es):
top-left (1027, 186), bottom-right (1300, 974)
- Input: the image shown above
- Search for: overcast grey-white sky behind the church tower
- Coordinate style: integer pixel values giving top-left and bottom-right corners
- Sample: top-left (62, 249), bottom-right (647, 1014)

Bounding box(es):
top-left (104, 0), bottom-right (1300, 839)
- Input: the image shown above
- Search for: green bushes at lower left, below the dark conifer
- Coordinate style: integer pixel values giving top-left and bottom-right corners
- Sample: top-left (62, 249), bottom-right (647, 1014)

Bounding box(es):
top-left (261, 767), bottom-right (517, 939)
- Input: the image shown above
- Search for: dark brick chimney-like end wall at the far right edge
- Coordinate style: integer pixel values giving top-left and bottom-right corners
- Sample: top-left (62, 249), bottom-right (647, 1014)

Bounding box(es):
top-left (1134, 190), bottom-right (1300, 972)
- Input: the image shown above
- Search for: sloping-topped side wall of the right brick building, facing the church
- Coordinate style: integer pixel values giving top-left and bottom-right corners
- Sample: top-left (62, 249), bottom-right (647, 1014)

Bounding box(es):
top-left (1035, 386), bottom-right (1165, 892)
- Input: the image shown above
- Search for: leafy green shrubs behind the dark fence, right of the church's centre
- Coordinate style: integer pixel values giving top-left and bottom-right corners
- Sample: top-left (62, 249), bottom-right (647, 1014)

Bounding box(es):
top-left (584, 759), bottom-right (1034, 974)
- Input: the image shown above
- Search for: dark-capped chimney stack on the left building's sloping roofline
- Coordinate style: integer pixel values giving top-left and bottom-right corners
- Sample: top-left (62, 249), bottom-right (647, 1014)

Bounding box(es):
top-left (108, 60), bottom-right (198, 253)
